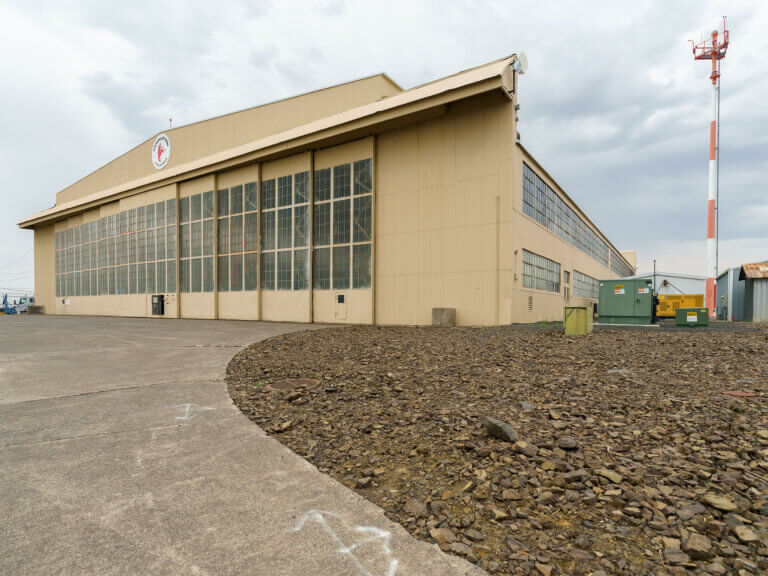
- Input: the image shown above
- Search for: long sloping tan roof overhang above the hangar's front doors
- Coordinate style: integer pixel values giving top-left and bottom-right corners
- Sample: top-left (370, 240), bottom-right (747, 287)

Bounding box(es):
top-left (18, 55), bottom-right (516, 229)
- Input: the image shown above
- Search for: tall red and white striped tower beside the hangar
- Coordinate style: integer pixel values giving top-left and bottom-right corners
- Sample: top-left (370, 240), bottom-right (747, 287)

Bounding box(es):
top-left (691, 17), bottom-right (729, 318)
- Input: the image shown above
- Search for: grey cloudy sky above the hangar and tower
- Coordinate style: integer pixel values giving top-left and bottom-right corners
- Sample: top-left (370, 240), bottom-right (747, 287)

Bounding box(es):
top-left (0, 0), bottom-right (768, 293)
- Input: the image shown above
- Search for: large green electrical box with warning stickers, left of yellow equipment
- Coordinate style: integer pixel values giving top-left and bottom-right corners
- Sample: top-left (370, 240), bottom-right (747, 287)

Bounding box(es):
top-left (597, 278), bottom-right (653, 324)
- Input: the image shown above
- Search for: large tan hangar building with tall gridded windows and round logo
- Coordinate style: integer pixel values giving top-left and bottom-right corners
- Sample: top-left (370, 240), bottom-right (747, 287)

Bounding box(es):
top-left (19, 55), bottom-right (635, 325)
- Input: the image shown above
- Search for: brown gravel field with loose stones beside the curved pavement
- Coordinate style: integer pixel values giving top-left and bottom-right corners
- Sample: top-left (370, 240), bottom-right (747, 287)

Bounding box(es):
top-left (227, 325), bottom-right (768, 576)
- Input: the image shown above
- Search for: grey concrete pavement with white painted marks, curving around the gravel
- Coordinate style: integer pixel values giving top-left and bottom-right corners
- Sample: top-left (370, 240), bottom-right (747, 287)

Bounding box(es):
top-left (0, 316), bottom-right (483, 576)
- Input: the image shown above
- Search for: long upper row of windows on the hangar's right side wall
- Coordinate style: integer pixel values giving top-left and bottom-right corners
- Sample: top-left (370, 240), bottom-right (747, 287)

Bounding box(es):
top-left (523, 163), bottom-right (634, 276)
